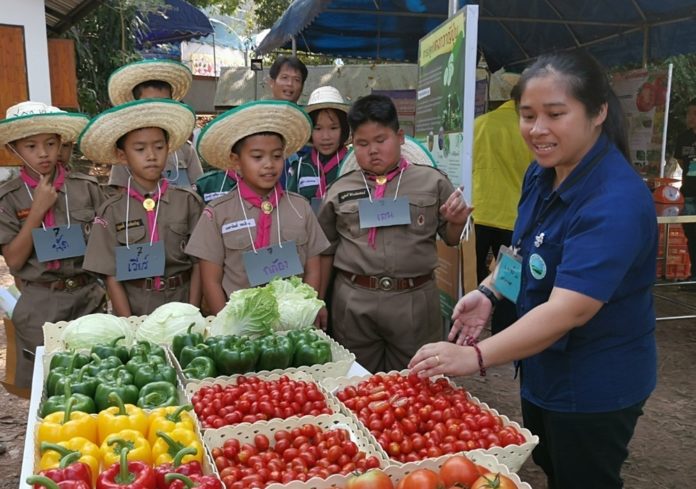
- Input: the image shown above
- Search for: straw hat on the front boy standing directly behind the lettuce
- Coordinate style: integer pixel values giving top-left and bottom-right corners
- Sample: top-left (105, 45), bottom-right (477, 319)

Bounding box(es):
top-left (196, 100), bottom-right (312, 169)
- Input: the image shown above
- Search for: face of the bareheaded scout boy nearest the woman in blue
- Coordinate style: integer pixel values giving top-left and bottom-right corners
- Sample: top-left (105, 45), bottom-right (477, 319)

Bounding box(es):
top-left (353, 121), bottom-right (404, 175)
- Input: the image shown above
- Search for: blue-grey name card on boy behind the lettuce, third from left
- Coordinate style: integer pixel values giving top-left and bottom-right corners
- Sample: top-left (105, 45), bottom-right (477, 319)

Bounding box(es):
top-left (242, 241), bottom-right (304, 287)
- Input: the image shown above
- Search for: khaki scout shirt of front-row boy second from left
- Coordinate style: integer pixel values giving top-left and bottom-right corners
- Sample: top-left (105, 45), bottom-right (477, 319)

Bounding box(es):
top-left (84, 181), bottom-right (203, 277)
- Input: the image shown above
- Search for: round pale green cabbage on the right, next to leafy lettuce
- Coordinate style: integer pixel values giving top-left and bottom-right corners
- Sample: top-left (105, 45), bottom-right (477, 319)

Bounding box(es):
top-left (135, 302), bottom-right (205, 345)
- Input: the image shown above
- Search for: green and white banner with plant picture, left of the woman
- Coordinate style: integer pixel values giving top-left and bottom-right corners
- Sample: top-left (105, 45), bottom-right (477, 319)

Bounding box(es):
top-left (416, 5), bottom-right (478, 201)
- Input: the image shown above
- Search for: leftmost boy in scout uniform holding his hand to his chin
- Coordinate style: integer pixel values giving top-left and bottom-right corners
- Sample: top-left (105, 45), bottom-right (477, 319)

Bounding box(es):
top-left (0, 102), bottom-right (105, 388)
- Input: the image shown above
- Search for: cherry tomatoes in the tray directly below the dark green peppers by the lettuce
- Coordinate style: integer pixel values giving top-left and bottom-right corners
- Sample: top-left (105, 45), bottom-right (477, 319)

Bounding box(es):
top-left (191, 375), bottom-right (332, 428)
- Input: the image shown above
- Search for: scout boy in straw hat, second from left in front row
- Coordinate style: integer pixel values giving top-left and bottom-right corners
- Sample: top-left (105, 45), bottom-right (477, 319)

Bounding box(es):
top-left (79, 99), bottom-right (202, 317)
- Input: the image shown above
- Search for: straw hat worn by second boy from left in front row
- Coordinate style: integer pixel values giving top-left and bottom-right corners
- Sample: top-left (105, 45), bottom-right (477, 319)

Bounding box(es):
top-left (78, 98), bottom-right (196, 164)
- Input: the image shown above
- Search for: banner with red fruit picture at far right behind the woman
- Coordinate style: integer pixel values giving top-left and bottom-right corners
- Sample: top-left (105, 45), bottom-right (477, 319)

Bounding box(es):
top-left (611, 69), bottom-right (670, 177)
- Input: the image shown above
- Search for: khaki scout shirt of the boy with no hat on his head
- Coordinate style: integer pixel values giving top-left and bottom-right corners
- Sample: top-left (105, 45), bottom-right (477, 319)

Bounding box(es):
top-left (318, 164), bottom-right (456, 278)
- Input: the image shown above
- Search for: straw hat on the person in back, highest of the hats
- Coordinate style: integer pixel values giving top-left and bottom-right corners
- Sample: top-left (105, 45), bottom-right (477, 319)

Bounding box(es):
top-left (109, 59), bottom-right (193, 105)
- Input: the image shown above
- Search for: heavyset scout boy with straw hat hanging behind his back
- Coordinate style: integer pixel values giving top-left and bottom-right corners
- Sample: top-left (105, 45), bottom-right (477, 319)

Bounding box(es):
top-left (319, 95), bottom-right (471, 372)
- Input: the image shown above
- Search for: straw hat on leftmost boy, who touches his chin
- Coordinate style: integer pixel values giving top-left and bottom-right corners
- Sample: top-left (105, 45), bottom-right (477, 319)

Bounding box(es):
top-left (0, 101), bottom-right (89, 146)
